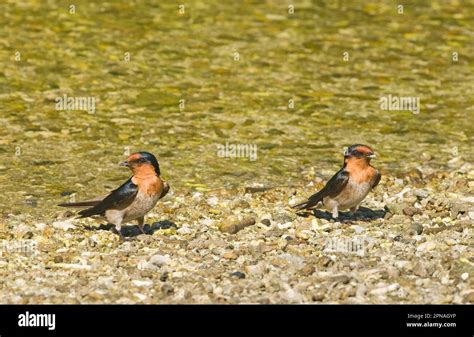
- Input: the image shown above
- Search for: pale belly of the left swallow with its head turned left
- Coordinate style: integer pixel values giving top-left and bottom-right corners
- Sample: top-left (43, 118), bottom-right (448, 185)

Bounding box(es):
top-left (105, 192), bottom-right (160, 224)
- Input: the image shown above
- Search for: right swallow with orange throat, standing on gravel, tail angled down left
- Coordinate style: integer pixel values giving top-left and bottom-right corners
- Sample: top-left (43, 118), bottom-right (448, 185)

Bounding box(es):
top-left (293, 144), bottom-right (381, 218)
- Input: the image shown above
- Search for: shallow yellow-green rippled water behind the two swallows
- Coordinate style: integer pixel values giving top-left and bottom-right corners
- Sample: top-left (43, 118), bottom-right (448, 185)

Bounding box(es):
top-left (0, 1), bottom-right (474, 216)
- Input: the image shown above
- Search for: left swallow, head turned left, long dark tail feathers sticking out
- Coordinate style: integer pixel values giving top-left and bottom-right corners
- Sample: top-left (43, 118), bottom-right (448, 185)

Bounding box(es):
top-left (58, 152), bottom-right (170, 240)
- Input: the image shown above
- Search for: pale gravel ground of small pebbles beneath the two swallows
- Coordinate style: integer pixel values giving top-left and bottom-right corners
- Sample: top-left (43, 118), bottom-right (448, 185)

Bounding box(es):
top-left (0, 162), bottom-right (474, 303)
